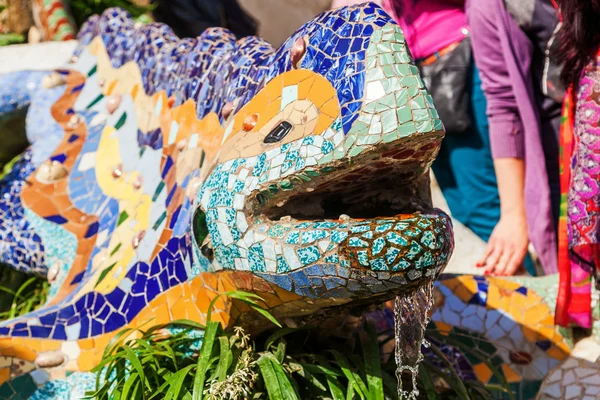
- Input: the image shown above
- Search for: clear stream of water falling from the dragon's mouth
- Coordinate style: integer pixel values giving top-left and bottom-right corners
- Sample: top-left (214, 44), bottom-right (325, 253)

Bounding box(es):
top-left (394, 282), bottom-right (433, 400)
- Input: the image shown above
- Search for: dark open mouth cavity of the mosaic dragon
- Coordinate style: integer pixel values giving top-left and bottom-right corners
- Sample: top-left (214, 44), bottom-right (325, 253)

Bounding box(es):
top-left (255, 139), bottom-right (434, 221)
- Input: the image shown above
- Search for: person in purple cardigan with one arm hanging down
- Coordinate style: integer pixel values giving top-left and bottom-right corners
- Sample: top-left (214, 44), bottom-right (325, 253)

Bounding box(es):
top-left (466, 0), bottom-right (562, 275)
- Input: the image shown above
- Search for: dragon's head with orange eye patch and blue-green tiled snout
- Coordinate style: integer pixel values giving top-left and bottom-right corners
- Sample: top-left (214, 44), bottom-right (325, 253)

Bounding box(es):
top-left (192, 6), bottom-right (453, 324)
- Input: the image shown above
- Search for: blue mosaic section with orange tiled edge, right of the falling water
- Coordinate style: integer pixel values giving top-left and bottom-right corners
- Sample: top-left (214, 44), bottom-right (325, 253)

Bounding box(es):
top-left (430, 275), bottom-right (572, 400)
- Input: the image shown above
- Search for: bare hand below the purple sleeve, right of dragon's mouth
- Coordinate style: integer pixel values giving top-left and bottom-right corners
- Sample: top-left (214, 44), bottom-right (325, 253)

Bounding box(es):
top-left (477, 213), bottom-right (529, 276)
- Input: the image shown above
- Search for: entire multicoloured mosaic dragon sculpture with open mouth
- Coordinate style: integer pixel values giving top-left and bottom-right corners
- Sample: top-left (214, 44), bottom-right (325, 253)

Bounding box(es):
top-left (0, 4), bottom-right (592, 399)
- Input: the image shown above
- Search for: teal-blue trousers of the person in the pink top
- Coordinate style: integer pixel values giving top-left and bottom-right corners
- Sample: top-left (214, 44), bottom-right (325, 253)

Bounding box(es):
top-left (433, 66), bottom-right (535, 275)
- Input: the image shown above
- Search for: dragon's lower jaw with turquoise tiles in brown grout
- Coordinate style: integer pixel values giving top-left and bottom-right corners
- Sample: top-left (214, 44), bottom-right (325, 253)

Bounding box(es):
top-left (239, 209), bottom-right (453, 318)
